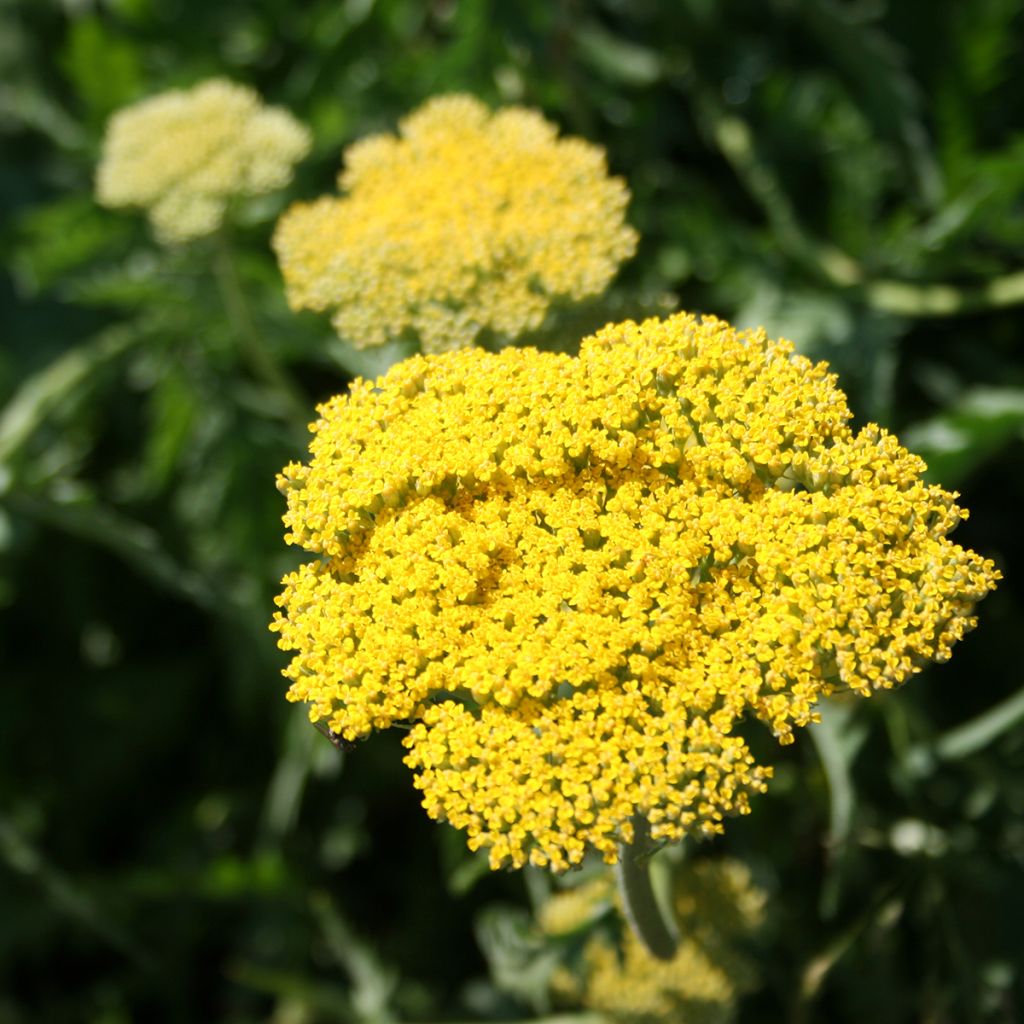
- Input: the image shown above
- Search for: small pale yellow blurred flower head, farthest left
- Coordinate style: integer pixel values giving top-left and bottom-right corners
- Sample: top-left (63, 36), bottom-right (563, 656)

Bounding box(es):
top-left (96, 79), bottom-right (310, 244)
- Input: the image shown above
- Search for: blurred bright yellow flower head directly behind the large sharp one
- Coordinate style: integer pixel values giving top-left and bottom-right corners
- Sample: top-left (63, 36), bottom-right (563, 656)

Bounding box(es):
top-left (274, 95), bottom-right (636, 352)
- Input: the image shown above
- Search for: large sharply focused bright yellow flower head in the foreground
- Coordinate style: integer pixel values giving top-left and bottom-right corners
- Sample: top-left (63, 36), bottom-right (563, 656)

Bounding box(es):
top-left (271, 314), bottom-right (998, 870)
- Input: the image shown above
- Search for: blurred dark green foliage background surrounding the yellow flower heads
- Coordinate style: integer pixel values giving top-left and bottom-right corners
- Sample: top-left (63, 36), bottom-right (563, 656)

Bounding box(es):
top-left (0, 0), bottom-right (1024, 1024)
